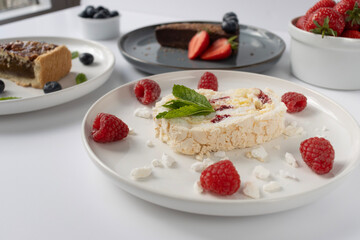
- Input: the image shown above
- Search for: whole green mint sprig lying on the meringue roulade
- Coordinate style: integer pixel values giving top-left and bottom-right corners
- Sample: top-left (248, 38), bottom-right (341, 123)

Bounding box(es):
top-left (156, 84), bottom-right (215, 119)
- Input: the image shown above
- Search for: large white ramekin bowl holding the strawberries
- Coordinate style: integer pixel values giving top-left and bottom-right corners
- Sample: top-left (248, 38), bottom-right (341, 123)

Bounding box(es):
top-left (288, 18), bottom-right (360, 90)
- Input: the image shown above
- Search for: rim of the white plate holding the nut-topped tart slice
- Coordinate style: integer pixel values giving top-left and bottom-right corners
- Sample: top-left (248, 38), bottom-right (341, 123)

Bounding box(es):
top-left (0, 35), bottom-right (115, 116)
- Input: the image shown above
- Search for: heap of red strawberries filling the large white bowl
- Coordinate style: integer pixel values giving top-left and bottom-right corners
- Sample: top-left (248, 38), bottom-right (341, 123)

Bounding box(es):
top-left (295, 0), bottom-right (360, 38)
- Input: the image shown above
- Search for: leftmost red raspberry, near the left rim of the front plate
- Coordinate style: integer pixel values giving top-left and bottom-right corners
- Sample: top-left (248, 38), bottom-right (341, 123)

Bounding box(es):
top-left (91, 113), bottom-right (129, 143)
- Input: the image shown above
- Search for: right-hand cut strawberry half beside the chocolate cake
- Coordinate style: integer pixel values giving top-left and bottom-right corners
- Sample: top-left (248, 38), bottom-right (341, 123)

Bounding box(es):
top-left (200, 36), bottom-right (237, 60)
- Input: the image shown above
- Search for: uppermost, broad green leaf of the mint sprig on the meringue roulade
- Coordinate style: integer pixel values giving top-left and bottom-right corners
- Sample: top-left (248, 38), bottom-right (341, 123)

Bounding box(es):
top-left (172, 84), bottom-right (212, 109)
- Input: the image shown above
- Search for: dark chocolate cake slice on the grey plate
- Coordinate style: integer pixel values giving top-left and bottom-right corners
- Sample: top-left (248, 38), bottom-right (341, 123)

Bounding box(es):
top-left (155, 23), bottom-right (239, 49)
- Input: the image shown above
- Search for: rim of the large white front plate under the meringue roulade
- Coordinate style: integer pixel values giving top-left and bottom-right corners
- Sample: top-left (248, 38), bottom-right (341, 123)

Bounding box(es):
top-left (81, 70), bottom-right (360, 216)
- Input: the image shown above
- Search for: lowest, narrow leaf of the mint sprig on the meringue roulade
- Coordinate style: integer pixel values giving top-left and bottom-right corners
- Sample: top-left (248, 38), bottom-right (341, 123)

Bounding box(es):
top-left (156, 105), bottom-right (212, 119)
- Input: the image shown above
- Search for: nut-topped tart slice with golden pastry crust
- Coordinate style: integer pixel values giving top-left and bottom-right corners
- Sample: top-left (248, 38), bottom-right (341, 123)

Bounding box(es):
top-left (0, 41), bottom-right (71, 88)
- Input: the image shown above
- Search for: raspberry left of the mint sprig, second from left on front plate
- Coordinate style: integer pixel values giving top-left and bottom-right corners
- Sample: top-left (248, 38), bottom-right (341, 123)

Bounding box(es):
top-left (134, 79), bottom-right (161, 105)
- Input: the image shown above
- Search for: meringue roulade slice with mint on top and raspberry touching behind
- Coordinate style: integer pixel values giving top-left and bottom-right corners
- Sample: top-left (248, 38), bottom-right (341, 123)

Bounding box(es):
top-left (153, 73), bottom-right (286, 156)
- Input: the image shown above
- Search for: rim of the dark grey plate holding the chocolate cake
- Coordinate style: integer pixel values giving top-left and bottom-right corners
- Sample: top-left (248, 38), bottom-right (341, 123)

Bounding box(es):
top-left (117, 20), bottom-right (286, 71)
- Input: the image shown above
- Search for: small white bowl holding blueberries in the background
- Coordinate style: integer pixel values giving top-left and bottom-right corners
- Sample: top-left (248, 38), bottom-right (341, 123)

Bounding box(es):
top-left (79, 16), bottom-right (120, 40)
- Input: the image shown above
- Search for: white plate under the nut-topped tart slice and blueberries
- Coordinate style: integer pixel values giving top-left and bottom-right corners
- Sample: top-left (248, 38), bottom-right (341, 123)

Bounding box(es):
top-left (0, 37), bottom-right (115, 115)
